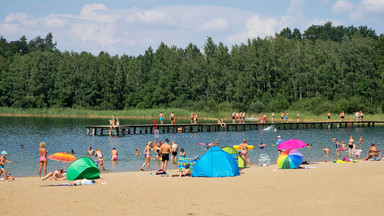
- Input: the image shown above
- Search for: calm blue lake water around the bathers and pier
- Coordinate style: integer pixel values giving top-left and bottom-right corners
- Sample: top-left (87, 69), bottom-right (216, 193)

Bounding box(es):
top-left (0, 117), bottom-right (384, 176)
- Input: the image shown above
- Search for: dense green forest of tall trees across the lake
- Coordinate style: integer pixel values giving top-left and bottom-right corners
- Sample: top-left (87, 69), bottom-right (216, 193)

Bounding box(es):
top-left (0, 22), bottom-right (384, 114)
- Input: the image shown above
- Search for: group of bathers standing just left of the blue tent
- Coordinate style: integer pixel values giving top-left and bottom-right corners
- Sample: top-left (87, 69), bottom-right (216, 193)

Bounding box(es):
top-left (140, 139), bottom-right (187, 171)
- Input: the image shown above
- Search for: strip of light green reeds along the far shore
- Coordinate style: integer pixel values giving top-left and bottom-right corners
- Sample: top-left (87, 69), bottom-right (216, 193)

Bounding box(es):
top-left (0, 107), bottom-right (384, 123)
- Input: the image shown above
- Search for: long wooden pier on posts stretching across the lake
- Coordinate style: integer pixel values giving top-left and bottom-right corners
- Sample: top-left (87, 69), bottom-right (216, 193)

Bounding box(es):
top-left (85, 121), bottom-right (384, 136)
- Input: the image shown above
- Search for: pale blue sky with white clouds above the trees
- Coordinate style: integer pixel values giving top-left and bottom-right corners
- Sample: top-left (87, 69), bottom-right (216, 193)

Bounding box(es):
top-left (0, 0), bottom-right (384, 56)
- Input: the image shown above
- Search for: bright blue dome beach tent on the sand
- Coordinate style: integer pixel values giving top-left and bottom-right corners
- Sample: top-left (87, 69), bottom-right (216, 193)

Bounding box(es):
top-left (191, 146), bottom-right (240, 177)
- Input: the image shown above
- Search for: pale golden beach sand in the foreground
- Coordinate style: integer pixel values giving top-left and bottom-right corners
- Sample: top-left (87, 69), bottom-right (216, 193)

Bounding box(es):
top-left (0, 161), bottom-right (384, 216)
